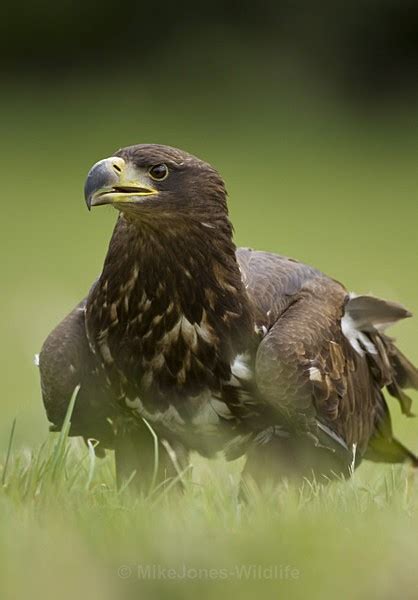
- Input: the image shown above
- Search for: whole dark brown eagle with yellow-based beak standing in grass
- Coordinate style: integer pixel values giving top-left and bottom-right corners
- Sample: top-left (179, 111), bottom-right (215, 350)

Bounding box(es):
top-left (39, 144), bottom-right (418, 489)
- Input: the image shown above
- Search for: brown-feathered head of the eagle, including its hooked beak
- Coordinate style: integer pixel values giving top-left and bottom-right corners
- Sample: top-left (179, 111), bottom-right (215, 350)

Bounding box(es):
top-left (84, 144), bottom-right (227, 221)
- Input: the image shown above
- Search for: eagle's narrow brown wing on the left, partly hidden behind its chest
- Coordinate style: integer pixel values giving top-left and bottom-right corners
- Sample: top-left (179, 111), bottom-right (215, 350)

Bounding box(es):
top-left (39, 300), bottom-right (114, 448)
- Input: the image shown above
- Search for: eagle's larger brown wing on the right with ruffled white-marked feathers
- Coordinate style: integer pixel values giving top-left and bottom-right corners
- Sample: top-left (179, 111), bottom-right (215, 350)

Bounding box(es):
top-left (237, 250), bottom-right (418, 460)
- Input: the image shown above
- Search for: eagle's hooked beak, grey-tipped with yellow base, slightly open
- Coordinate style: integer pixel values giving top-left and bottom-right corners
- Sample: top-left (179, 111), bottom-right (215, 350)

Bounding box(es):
top-left (84, 156), bottom-right (158, 210)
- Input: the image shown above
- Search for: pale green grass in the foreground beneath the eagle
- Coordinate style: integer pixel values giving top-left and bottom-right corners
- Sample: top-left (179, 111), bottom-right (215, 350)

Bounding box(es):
top-left (0, 418), bottom-right (418, 599)
